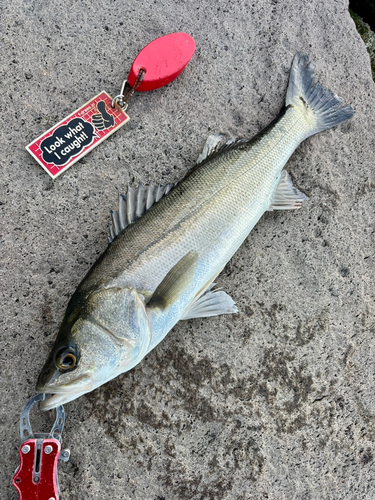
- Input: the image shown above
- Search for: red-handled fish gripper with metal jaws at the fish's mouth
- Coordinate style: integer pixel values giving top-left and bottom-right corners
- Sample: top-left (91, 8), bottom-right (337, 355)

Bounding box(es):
top-left (13, 394), bottom-right (70, 500)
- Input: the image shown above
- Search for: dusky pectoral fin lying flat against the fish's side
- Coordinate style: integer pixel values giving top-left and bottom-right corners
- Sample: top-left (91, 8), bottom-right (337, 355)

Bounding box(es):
top-left (147, 250), bottom-right (198, 309)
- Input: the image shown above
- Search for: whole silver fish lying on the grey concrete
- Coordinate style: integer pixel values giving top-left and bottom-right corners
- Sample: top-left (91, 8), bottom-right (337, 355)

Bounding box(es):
top-left (37, 54), bottom-right (354, 410)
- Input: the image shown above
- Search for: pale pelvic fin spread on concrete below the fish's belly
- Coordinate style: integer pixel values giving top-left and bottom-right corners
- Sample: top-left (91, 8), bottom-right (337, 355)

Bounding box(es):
top-left (182, 283), bottom-right (238, 319)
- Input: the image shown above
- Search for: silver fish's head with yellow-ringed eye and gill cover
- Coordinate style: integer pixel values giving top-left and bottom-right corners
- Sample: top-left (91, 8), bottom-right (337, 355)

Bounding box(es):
top-left (37, 288), bottom-right (152, 410)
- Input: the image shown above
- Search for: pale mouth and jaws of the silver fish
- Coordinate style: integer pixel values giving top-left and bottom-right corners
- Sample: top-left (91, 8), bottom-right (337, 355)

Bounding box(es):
top-left (37, 375), bottom-right (94, 411)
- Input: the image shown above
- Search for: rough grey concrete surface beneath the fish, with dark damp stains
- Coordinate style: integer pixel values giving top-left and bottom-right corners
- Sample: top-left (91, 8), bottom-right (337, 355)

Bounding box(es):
top-left (0, 0), bottom-right (375, 500)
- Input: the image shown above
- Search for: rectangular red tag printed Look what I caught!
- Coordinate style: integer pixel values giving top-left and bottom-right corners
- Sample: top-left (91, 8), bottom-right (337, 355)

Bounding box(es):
top-left (26, 91), bottom-right (129, 179)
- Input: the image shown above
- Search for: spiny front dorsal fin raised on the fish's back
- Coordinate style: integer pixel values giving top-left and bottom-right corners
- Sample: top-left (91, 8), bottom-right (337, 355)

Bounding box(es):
top-left (108, 182), bottom-right (175, 243)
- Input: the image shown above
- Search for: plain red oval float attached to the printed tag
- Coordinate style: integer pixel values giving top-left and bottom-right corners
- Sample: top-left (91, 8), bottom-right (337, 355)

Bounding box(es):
top-left (128, 33), bottom-right (195, 92)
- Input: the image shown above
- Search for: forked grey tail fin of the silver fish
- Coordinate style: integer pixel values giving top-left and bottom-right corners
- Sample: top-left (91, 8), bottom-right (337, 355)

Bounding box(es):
top-left (286, 52), bottom-right (354, 137)
